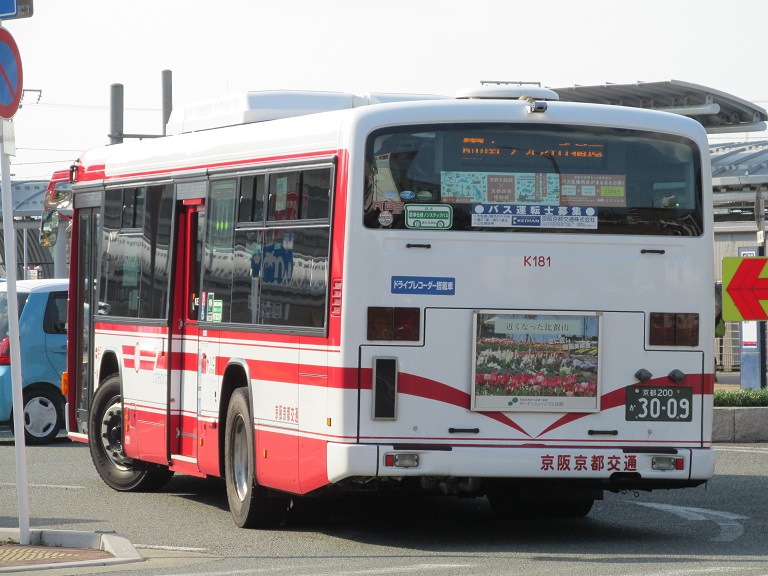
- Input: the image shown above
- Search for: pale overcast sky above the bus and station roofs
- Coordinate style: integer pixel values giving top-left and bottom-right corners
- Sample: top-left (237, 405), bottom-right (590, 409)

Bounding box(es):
top-left (2, 0), bottom-right (768, 180)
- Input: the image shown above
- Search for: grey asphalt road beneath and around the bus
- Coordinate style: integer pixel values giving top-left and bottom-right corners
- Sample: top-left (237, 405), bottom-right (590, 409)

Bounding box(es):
top-left (0, 431), bottom-right (768, 576)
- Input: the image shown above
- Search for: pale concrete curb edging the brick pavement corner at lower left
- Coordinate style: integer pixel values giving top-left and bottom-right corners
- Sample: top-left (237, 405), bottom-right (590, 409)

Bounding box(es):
top-left (0, 528), bottom-right (144, 574)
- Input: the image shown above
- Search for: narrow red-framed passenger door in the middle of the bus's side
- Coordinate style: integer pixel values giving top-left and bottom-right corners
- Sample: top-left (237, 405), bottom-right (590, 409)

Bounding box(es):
top-left (169, 199), bottom-right (205, 474)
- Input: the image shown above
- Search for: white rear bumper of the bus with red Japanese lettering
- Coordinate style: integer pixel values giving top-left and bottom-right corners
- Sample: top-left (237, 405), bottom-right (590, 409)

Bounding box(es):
top-left (327, 443), bottom-right (715, 488)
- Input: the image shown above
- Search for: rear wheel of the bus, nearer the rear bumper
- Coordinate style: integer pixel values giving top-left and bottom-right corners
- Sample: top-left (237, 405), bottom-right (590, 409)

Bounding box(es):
top-left (224, 388), bottom-right (285, 528)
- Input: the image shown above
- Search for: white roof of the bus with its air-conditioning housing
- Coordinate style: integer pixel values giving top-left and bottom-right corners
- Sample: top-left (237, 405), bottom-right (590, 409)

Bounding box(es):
top-left (72, 91), bottom-right (708, 182)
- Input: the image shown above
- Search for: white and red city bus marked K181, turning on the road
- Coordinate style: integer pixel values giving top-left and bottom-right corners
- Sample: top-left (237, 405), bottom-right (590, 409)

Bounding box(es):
top-left (63, 87), bottom-right (714, 526)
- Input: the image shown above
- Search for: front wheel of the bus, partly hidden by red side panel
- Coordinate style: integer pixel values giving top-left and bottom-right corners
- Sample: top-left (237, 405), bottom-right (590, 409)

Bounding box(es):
top-left (88, 374), bottom-right (173, 492)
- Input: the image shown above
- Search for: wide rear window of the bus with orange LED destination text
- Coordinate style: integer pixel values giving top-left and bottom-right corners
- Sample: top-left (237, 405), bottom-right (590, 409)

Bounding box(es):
top-left (363, 124), bottom-right (703, 236)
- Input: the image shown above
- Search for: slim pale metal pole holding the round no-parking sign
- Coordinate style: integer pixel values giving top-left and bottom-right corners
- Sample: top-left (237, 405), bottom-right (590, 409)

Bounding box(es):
top-left (0, 120), bottom-right (29, 544)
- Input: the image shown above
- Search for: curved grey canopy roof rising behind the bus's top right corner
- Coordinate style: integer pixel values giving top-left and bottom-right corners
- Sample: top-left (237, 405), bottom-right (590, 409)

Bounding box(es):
top-left (552, 80), bottom-right (768, 134)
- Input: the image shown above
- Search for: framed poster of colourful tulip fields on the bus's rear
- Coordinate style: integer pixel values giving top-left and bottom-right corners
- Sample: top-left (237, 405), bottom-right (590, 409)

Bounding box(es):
top-left (472, 310), bottom-right (601, 412)
